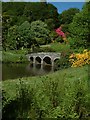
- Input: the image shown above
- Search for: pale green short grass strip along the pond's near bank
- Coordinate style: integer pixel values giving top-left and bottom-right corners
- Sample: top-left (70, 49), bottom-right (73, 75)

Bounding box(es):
top-left (2, 66), bottom-right (88, 97)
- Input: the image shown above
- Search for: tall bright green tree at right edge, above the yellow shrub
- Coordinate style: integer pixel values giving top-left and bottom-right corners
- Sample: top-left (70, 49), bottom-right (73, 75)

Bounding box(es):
top-left (69, 2), bottom-right (90, 48)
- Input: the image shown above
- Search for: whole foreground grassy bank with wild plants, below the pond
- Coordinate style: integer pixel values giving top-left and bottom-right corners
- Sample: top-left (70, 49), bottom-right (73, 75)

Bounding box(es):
top-left (2, 66), bottom-right (90, 120)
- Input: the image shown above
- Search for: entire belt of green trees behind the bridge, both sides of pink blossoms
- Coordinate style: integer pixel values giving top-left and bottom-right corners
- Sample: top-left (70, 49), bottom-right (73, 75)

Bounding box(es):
top-left (2, 2), bottom-right (90, 50)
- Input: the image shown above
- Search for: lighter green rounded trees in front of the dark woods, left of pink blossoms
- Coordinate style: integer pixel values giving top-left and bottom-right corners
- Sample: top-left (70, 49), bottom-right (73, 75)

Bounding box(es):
top-left (6, 20), bottom-right (50, 50)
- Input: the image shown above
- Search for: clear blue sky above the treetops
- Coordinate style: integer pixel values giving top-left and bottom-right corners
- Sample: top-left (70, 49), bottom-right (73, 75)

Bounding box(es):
top-left (3, 0), bottom-right (85, 13)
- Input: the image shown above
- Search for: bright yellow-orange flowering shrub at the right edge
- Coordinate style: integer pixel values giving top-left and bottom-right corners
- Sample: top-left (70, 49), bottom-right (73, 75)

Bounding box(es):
top-left (69, 49), bottom-right (90, 67)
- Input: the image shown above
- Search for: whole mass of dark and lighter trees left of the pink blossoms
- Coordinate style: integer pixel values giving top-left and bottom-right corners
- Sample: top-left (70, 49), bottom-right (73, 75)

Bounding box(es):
top-left (2, 2), bottom-right (58, 50)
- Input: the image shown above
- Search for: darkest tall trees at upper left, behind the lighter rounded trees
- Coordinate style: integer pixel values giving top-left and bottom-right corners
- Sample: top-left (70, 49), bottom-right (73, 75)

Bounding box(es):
top-left (2, 2), bottom-right (58, 26)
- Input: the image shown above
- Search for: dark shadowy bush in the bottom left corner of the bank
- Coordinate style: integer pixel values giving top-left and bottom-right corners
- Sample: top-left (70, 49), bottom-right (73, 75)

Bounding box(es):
top-left (2, 80), bottom-right (34, 120)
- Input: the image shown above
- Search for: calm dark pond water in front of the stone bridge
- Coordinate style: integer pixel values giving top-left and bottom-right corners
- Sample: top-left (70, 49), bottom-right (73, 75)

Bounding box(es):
top-left (2, 63), bottom-right (54, 80)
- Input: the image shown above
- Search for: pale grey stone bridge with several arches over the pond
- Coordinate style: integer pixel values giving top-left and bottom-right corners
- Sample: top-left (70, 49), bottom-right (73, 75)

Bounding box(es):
top-left (27, 52), bottom-right (61, 66)
